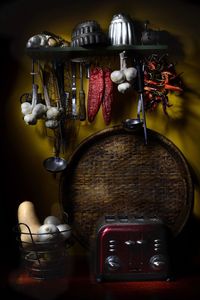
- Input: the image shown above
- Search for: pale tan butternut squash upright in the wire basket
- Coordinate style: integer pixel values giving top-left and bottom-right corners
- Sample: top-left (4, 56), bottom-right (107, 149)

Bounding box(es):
top-left (18, 201), bottom-right (41, 246)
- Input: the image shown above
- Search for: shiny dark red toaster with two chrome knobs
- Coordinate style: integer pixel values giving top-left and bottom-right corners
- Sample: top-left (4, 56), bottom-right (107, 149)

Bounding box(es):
top-left (95, 216), bottom-right (170, 282)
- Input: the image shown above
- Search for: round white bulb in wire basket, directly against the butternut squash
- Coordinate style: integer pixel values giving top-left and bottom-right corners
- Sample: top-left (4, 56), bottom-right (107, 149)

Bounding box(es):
top-left (37, 224), bottom-right (59, 242)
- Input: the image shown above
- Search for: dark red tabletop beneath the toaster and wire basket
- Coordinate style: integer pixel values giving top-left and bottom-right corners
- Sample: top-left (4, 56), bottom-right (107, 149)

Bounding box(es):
top-left (1, 255), bottom-right (200, 300)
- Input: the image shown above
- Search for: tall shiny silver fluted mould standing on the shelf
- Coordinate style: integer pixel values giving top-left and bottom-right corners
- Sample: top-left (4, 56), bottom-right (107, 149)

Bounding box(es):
top-left (108, 13), bottom-right (136, 46)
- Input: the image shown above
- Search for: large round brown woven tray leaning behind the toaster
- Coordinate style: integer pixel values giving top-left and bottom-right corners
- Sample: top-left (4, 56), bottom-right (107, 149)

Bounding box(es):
top-left (61, 126), bottom-right (193, 247)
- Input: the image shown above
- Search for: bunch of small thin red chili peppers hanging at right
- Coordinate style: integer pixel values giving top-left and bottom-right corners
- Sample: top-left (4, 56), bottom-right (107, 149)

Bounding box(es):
top-left (144, 54), bottom-right (183, 114)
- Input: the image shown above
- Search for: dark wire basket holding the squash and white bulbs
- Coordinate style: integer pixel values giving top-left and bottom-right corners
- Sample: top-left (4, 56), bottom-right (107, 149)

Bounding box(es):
top-left (15, 223), bottom-right (73, 279)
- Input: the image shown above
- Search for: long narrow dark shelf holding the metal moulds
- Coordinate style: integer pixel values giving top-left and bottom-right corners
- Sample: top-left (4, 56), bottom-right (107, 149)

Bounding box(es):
top-left (26, 45), bottom-right (168, 61)
